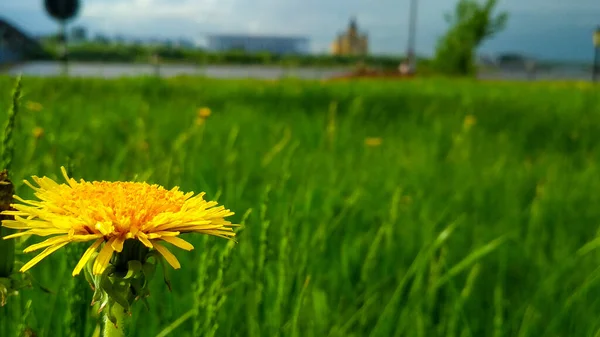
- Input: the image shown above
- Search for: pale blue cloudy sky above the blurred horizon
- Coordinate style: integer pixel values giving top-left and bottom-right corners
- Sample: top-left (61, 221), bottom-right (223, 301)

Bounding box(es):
top-left (0, 0), bottom-right (600, 61)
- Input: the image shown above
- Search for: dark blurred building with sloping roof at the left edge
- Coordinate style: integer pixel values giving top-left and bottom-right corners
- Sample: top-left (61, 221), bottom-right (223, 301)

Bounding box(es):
top-left (0, 19), bottom-right (45, 65)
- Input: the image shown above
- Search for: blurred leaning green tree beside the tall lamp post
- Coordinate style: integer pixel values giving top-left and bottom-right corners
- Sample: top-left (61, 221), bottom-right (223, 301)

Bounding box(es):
top-left (434, 0), bottom-right (508, 75)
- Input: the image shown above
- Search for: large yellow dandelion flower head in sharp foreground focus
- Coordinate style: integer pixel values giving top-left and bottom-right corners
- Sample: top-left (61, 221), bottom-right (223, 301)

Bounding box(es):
top-left (0, 167), bottom-right (237, 276)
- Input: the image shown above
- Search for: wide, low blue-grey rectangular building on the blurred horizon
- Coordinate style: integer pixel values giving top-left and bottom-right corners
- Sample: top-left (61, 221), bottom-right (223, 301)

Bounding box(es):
top-left (207, 35), bottom-right (308, 55)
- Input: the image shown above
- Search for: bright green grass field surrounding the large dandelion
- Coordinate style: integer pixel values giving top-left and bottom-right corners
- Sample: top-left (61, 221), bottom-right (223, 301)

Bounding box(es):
top-left (0, 77), bottom-right (600, 337)
